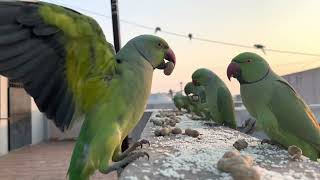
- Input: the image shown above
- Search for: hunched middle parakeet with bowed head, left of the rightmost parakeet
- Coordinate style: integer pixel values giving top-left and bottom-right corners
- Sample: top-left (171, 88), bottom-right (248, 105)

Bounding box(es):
top-left (192, 68), bottom-right (237, 129)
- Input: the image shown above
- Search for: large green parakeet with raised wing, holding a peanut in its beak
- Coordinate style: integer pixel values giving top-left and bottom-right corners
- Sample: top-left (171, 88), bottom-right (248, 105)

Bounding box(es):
top-left (0, 1), bottom-right (175, 180)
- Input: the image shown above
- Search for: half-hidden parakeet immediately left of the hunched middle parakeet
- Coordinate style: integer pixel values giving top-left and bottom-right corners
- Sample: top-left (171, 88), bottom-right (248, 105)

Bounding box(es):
top-left (184, 82), bottom-right (211, 120)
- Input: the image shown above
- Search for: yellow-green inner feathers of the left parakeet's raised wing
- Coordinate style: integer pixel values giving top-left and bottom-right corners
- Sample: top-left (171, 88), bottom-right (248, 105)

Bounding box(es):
top-left (39, 4), bottom-right (116, 119)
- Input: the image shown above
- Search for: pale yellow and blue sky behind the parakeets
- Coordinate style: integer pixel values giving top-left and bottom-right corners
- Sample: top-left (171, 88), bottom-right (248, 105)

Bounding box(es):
top-left (46, 0), bottom-right (320, 94)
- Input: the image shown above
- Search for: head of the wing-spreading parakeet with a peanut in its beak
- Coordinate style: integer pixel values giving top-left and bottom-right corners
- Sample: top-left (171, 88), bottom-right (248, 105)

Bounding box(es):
top-left (128, 35), bottom-right (176, 75)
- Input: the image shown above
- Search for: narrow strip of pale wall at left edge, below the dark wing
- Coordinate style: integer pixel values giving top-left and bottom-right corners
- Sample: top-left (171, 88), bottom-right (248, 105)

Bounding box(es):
top-left (0, 76), bottom-right (8, 156)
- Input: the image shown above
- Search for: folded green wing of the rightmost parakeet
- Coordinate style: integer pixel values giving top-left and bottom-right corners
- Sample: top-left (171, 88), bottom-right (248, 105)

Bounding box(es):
top-left (270, 80), bottom-right (320, 150)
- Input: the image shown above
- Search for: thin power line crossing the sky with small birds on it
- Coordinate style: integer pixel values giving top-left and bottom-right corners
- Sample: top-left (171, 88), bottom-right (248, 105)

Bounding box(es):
top-left (48, 0), bottom-right (320, 57)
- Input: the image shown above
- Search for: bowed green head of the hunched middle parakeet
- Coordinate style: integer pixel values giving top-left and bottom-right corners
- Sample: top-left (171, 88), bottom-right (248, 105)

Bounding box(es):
top-left (192, 68), bottom-right (216, 86)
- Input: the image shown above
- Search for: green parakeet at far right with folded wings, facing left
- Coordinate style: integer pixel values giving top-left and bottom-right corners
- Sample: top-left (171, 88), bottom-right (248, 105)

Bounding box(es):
top-left (227, 52), bottom-right (320, 160)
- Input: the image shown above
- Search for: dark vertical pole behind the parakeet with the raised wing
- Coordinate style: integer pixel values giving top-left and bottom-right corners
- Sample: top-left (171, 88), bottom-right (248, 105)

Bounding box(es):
top-left (110, 0), bottom-right (129, 152)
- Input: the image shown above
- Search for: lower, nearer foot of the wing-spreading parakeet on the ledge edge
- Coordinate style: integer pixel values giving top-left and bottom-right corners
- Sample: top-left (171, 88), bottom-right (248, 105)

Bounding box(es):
top-left (99, 152), bottom-right (149, 174)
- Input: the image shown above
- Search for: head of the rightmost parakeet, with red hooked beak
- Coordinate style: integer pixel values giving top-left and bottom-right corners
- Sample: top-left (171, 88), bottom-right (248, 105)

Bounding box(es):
top-left (227, 52), bottom-right (270, 84)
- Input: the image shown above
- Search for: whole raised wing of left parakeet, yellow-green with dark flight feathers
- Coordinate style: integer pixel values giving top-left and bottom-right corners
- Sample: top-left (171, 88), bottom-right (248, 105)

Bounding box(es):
top-left (0, 2), bottom-right (116, 130)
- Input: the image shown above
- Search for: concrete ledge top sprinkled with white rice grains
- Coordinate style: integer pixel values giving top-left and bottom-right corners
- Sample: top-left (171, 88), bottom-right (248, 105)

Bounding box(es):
top-left (120, 112), bottom-right (320, 180)
